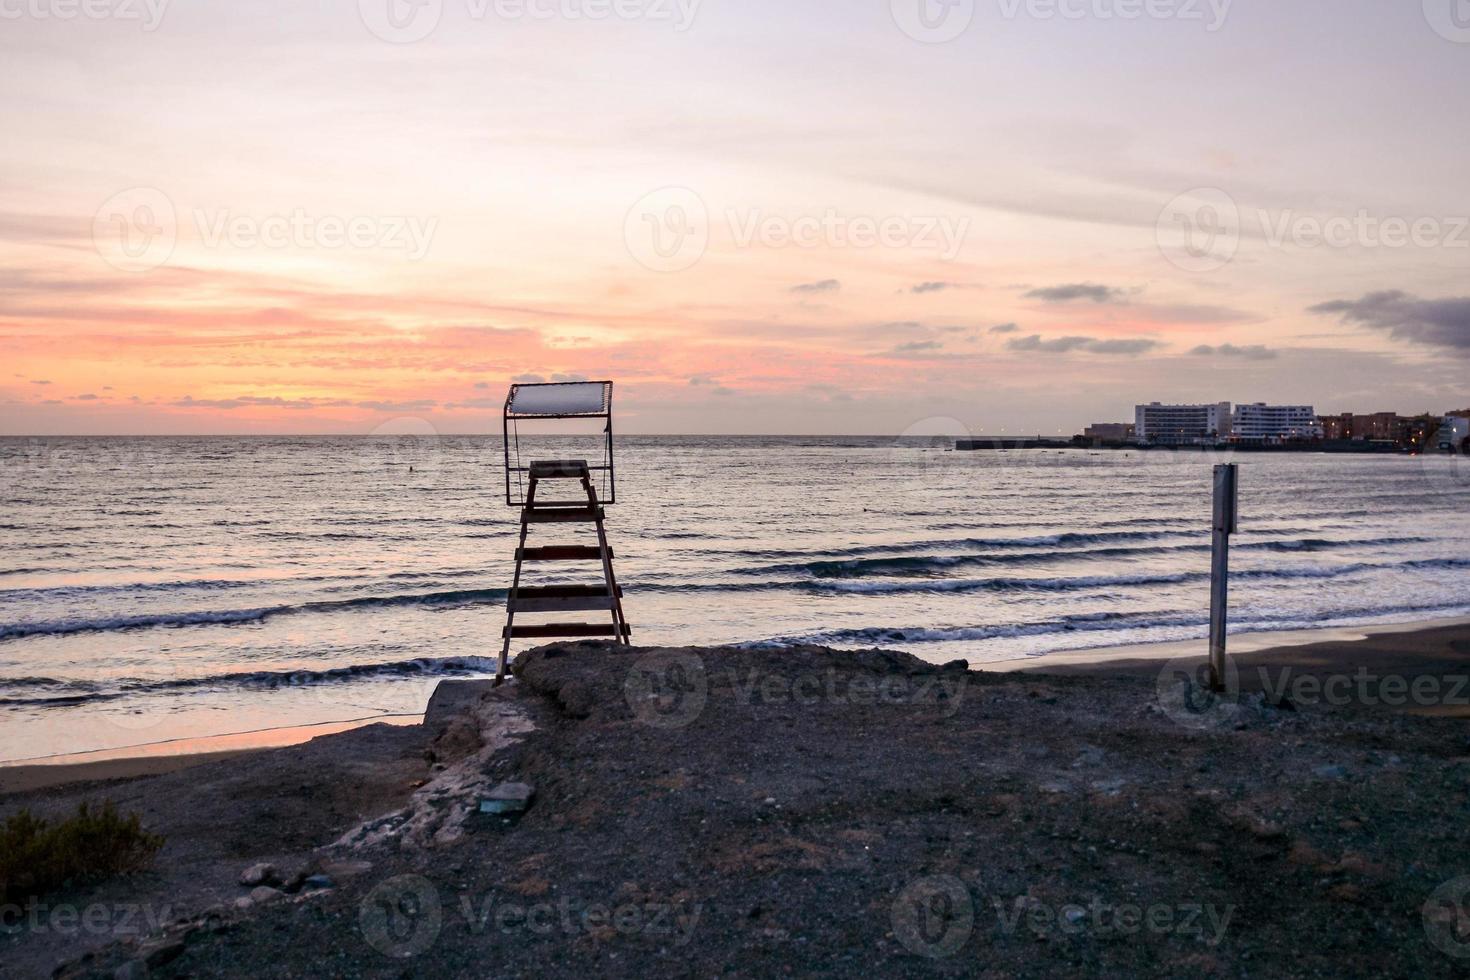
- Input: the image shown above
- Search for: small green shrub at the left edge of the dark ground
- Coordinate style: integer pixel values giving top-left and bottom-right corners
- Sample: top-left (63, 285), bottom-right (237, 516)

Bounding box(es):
top-left (0, 802), bottom-right (163, 901)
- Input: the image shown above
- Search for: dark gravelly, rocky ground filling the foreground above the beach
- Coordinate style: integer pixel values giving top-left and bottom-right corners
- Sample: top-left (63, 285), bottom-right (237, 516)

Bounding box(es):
top-left (0, 644), bottom-right (1470, 980)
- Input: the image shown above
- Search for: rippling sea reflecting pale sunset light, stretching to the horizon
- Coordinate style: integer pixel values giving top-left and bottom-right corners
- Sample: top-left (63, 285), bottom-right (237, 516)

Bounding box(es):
top-left (0, 433), bottom-right (1470, 761)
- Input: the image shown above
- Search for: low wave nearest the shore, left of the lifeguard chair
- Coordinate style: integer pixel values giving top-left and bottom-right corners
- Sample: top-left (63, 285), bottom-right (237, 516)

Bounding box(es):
top-left (0, 657), bottom-right (497, 707)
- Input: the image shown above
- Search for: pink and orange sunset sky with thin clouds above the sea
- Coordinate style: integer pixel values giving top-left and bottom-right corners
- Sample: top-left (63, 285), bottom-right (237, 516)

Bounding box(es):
top-left (0, 0), bottom-right (1470, 435)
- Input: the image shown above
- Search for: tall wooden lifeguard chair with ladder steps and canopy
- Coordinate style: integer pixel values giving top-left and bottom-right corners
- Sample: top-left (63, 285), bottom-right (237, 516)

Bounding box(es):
top-left (495, 381), bottom-right (632, 683)
